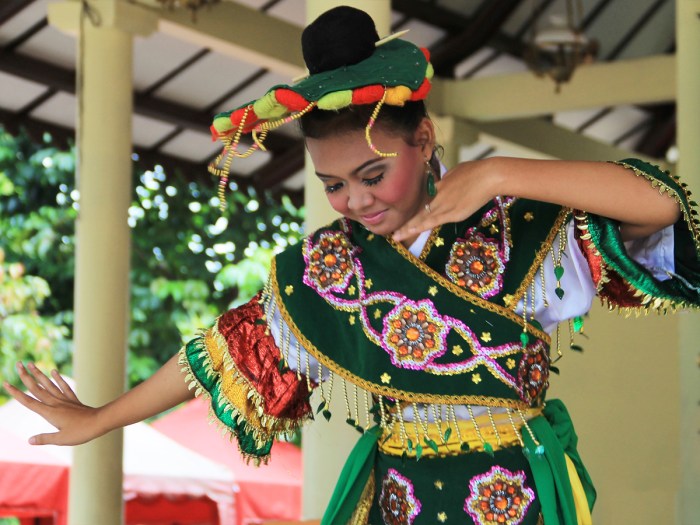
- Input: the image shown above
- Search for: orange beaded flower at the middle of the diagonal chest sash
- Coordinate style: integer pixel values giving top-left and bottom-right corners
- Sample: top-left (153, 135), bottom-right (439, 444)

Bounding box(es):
top-left (382, 300), bottom-right (446, 370)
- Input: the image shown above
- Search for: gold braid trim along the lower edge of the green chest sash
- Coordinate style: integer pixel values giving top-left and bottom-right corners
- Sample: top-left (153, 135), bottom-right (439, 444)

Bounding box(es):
top-left (270, 259), bottom-right (532, 410)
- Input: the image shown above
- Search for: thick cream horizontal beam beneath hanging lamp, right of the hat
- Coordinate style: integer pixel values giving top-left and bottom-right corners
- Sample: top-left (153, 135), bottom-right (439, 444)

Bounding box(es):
top-left (430, 55), bottom-right (676, 121)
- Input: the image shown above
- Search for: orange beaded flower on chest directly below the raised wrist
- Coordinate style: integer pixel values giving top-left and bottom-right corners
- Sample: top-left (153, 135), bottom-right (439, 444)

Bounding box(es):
top-left (445, 233), bottom-right (505, 299)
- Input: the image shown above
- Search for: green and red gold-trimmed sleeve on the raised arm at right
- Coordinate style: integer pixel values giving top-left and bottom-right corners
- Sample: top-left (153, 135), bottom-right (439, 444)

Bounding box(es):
top-left (574, 159), bottom-right (700, 312)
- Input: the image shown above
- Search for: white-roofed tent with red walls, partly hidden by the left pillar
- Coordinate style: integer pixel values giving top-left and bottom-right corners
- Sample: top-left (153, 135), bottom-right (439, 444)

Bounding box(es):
top-left (0, 392), bottom-right (238, 525)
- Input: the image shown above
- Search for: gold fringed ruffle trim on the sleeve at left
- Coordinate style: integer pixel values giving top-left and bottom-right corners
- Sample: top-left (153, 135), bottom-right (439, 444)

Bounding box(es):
top-left (178, 325), bottom-right (307, 460)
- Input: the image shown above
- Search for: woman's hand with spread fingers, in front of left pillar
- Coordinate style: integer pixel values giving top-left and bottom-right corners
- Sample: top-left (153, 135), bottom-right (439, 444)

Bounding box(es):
top-left (4, 363), bottom-right (104, 445)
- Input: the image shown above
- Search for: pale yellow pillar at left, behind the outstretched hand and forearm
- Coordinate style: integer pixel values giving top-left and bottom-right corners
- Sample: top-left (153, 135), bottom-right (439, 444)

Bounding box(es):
top-left (49, 0), bottom-right (154, 525)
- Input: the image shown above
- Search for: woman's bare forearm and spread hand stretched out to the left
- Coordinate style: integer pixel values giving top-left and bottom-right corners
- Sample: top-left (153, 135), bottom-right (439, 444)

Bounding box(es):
top-left (4, 355), bottom-right (194, 445)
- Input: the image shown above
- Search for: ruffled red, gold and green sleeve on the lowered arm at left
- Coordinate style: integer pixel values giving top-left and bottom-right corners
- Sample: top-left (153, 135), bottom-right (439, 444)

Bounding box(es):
top-left (180, 295), bottom-right (311, 463)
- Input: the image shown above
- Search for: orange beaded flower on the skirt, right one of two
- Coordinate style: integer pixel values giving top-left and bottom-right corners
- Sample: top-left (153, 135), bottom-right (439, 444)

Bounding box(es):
top-left (464, 465), bottom-right (535, 525)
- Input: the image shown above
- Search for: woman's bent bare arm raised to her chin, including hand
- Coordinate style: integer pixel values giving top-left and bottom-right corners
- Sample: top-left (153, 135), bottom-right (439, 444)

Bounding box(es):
top-left (394, 157), bottom-right (680, 241)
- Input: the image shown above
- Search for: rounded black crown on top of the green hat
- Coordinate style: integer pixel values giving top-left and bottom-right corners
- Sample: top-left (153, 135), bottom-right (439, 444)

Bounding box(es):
top-left (301, 6), bottom-right (379, 75)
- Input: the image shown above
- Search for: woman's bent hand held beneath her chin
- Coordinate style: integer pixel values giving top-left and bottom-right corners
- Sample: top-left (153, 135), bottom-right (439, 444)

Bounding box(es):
top-left (393, 159), bottom-right (499, 242)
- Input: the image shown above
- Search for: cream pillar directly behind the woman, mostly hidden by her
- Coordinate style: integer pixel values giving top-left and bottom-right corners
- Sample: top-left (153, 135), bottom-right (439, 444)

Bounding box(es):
top-left (302, 0), bottom-right (391, 518)
